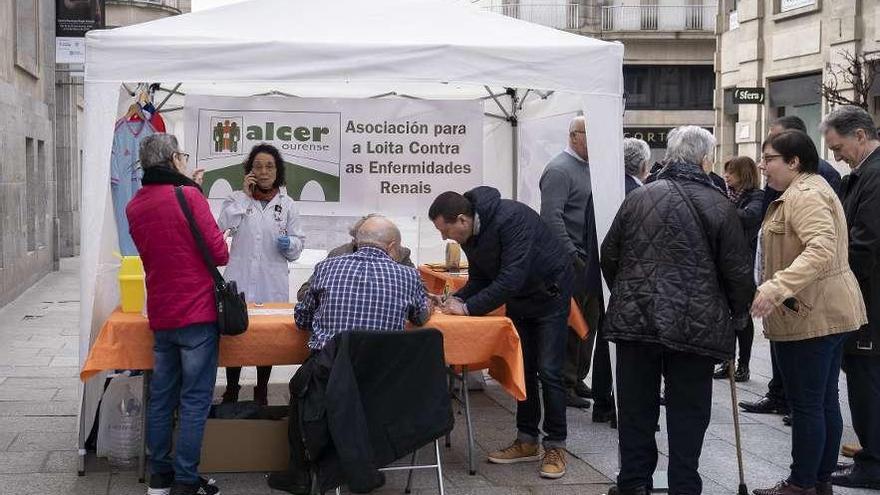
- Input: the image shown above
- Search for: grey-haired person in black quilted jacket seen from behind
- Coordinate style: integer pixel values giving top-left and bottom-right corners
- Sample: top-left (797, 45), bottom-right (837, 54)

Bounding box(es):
top-left (601, 126), bottom-right (754, 495)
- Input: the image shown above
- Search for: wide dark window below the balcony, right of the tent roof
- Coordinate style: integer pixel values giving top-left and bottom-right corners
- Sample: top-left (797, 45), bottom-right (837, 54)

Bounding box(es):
top-left (623, 65), bottom-right (715, 110)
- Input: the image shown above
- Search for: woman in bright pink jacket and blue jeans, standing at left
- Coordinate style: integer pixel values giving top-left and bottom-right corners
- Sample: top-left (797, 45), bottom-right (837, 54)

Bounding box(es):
top-left (125, 134), bottom-right (229, 495)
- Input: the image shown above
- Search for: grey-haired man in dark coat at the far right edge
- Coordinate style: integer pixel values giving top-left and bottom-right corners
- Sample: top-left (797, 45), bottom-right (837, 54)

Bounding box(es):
top-left (822, 105), bottom-right (880, 490)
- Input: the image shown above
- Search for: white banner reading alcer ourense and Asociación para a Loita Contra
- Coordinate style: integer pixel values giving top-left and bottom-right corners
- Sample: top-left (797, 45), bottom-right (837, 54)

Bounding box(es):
top-left (184, 95), bottom-right (483, 215)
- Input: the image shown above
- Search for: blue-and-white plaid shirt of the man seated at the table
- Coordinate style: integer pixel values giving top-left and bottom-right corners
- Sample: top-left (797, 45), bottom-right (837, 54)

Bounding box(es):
top-left (294, 246), bottom-right (429, 349)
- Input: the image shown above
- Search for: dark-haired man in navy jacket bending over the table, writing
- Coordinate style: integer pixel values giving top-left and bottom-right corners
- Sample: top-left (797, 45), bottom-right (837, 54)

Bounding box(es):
top-left (428, 186), bottom-right (574, 479)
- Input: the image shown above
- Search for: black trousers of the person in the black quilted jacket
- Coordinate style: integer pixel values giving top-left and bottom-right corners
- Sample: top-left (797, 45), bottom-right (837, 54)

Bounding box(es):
top-left (617, 342), bottom-right (715, 495)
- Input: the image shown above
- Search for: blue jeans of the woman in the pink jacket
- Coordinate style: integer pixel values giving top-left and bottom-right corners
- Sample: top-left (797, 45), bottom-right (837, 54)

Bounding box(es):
top-left (147, 323), bottom-right (220, 484)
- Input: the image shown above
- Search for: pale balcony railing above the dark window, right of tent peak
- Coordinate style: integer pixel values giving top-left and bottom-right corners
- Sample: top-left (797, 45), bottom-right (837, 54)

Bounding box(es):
top-left (602, 5), bottom-right (718, 32)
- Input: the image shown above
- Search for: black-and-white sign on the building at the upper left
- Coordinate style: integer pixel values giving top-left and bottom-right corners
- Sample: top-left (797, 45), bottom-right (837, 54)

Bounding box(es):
top-left (55, 0), bottom-right (104, 64)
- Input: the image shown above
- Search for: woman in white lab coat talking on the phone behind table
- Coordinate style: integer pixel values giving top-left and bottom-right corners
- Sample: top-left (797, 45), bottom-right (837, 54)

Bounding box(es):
top-left (217, 143), bottom-right (305, 405)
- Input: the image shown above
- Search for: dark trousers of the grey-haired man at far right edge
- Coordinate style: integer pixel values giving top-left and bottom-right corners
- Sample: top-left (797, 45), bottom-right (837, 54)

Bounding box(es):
top-left (843, 355), bottom-right (880, 479)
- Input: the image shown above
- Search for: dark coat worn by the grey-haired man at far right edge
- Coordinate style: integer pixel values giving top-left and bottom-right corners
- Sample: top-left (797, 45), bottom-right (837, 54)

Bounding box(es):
top-left (840, 148), bottom-right (880, 356)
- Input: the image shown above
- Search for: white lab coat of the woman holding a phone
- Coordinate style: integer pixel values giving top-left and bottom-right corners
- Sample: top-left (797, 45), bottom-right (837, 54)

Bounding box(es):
top-left (217, 191), bottom-right (305, 303)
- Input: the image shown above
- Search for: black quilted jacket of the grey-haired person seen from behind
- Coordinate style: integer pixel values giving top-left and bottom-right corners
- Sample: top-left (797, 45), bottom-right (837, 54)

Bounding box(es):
top-left (602, 163), bottom-right (755, 360)
